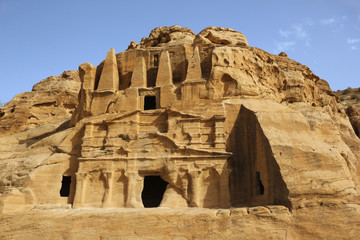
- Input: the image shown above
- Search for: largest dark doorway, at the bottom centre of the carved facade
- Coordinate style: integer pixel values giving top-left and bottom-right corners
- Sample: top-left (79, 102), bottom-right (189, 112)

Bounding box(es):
top-left (141, 176), bottom-right (168, 208)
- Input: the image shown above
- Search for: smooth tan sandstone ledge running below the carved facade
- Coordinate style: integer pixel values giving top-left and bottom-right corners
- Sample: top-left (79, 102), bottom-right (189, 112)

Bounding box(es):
top-left (0, 204), bottom-right (360, 240)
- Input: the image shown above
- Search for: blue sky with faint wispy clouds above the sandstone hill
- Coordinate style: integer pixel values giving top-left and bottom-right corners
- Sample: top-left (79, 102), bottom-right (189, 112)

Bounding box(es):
top-left (0, 0), bottom-right (360, 101)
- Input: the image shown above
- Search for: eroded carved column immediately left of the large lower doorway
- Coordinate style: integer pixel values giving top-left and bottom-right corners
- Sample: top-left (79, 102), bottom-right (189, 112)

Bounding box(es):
top-left (125, 171), bottom-right (144, 208)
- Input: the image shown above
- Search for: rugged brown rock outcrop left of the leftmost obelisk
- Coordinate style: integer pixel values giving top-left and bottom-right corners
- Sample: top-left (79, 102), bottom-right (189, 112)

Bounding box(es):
top-left (0, 71), bottom-right (80, 136)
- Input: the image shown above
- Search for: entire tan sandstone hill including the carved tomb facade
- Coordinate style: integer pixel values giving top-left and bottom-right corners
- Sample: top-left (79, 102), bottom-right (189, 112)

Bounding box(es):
top-left (0, 26), bottom-right (360, 239)
